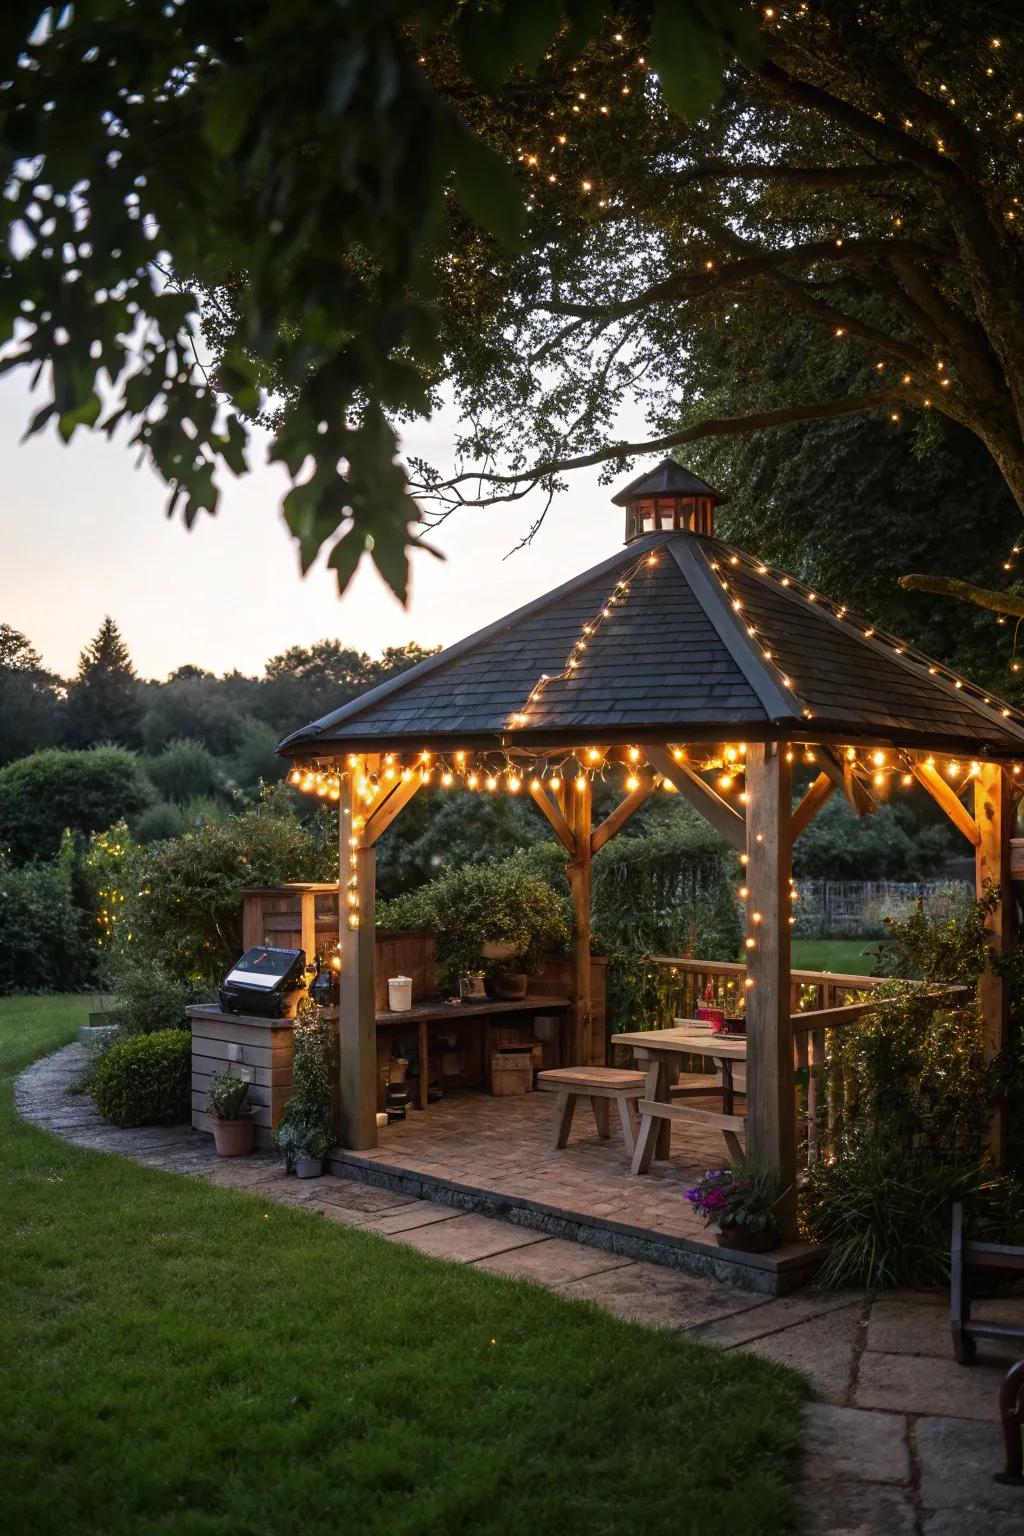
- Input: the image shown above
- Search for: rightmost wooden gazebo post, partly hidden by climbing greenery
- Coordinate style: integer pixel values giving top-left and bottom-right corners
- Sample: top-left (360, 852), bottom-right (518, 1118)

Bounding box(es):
top-left (975, 763), bottom-right (1016, 1167)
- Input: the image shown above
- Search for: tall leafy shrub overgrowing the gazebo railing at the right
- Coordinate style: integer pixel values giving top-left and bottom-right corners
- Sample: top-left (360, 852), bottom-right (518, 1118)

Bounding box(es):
top-left (801, 892), bottom-right (1024, 1287)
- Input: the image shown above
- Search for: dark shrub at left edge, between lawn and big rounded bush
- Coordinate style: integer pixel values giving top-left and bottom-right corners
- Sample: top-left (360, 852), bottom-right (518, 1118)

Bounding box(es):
top-left (0, 839), bottom-right (95, 995)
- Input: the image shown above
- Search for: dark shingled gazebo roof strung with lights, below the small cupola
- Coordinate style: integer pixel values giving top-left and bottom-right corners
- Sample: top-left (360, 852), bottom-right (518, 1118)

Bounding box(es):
top-left (279, 528), bottom-right (1024, 759)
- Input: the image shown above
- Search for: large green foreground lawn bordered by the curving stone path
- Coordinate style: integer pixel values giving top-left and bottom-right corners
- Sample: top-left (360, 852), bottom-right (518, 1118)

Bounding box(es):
top-left (0, 998), bottom-right (801, 1536)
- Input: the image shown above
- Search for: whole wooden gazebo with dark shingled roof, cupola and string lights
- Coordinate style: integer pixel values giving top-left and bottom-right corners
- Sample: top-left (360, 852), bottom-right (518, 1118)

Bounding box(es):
top-left (279, 459), bottom-right (1024, 1222)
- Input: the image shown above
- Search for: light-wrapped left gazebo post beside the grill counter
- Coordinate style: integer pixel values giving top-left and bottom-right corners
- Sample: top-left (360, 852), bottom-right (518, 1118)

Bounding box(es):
top-left (338, 759), bottom-right (376, 1152)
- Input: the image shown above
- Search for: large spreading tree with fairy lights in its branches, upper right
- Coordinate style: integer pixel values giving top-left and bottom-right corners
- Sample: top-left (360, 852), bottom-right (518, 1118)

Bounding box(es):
top-left (421, 0), bottom-right (1024, 543)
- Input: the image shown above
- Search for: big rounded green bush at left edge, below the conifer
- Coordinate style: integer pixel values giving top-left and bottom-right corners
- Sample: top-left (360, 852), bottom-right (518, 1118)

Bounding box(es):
top-left (0, 746), bottom-right (154, 862)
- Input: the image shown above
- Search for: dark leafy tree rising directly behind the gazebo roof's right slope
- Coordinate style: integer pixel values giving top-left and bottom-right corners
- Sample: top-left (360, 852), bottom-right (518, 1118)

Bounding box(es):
top-left (672, 307), bottom-right (1019, 699)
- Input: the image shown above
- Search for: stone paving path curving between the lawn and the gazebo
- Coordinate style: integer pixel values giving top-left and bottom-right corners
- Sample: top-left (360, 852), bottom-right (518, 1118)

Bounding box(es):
top-left (15, 1044), bottom-right (1024, 1536)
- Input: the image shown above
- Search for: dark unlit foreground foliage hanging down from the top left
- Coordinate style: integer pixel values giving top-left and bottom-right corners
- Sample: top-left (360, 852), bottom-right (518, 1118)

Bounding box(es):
top-left (0, 0), bottom-right (757, 598)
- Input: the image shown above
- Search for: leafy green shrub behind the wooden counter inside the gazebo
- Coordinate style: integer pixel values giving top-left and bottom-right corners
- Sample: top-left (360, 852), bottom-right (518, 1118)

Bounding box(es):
top-left (378, 852), bottom-right (571, 986)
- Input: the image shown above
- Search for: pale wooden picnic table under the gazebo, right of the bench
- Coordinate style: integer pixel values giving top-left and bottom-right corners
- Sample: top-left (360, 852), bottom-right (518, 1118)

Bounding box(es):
top-left (611, 1018), bottom-right (746, 1174)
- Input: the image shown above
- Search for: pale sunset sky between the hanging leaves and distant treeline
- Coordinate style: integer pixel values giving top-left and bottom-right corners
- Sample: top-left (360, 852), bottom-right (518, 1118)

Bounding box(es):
top-left (0, 365), bottom-right (639, 677)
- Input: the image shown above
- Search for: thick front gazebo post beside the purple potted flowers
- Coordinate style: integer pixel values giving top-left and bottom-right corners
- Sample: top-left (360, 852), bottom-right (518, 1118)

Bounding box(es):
top-left (746, 742), bottom-right (797, 1238)
